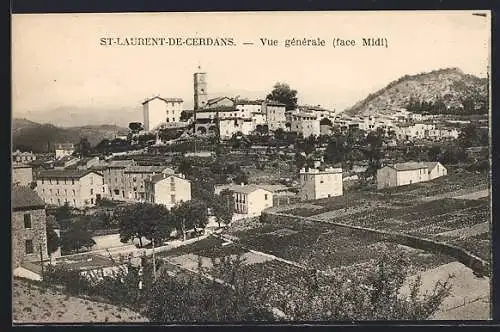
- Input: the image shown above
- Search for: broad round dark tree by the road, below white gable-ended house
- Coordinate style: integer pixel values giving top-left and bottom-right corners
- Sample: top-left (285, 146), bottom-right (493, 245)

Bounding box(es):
top-left (115, 203), bottom-right (175, 247)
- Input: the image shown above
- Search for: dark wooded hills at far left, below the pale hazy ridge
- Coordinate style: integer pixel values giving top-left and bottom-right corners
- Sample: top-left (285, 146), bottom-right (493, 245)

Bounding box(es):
top-left (12, 118), bottom-right (128, 152)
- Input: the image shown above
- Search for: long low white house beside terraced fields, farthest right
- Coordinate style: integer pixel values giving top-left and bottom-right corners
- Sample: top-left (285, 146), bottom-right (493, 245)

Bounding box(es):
top-left (377, 162), bottom-right (447, 189)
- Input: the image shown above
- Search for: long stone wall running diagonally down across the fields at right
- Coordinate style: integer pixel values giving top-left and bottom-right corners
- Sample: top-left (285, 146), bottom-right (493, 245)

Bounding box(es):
top-left (260, 211), bottom-right (491, 276)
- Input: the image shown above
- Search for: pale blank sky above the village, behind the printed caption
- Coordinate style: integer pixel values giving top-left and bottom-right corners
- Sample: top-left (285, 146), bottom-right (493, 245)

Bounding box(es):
top-left (12, 11), bottom-right (491, 116)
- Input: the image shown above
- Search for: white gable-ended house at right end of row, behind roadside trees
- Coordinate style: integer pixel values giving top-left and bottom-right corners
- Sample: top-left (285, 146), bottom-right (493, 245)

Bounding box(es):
top-left (144, 173), bottom-right (191, 210)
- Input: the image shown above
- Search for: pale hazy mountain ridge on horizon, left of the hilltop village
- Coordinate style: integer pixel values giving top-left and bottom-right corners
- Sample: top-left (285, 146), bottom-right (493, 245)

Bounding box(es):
top-left (14, 105), bottom-right (143, 127)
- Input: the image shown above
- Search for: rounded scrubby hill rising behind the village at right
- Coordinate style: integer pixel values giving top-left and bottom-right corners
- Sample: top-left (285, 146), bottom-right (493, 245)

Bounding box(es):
top-left (345, 68), bottom-right (488, 116)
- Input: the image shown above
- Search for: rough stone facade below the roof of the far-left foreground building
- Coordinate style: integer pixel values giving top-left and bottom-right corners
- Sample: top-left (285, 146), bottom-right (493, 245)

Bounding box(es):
top-left (11, 209), bottom-right (48, 270)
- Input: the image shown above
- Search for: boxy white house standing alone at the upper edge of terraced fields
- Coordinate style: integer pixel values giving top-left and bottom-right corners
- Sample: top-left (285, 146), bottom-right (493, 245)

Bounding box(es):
top-left (299, 167), bottom-right (343, 200)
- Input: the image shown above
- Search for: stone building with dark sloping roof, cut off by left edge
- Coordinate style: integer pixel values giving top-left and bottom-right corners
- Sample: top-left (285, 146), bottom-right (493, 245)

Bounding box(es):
top-left (11, 185), bottom-right (48, 270)
